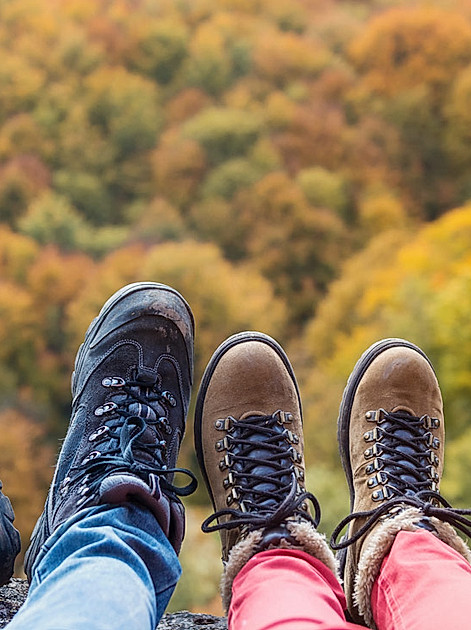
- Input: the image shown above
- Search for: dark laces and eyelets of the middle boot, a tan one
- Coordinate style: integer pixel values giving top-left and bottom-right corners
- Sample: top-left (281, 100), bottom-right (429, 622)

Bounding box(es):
top-left (201, 412), bottom-right (320, 532)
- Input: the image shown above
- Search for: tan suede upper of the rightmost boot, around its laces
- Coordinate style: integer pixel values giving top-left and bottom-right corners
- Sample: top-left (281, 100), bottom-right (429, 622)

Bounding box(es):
top-left (344, 347), bottom-right (444, 623)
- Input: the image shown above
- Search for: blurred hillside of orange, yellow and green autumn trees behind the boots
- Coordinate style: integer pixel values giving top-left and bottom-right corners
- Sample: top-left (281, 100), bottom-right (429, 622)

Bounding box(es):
top-left (0, 0), bottom-right (471, 612)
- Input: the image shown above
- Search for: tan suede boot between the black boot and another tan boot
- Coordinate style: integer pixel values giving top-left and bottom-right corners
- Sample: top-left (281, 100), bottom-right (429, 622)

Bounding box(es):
top-left (195, 332), bottom-right (335, 609)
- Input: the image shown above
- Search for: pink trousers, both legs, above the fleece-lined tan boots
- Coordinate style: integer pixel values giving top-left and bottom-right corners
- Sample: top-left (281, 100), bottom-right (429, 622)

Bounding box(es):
top-left (228, 531), bottom-right (471, 630)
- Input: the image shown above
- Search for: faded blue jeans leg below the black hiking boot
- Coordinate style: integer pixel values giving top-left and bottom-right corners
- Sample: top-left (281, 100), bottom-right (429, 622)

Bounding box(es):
top-left (7, 503), bottom-right (181, 630)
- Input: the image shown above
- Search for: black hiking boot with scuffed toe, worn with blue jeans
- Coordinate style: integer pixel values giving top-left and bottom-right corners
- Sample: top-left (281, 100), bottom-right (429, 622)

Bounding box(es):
top-left (25, 282), bottom-right (196, 577)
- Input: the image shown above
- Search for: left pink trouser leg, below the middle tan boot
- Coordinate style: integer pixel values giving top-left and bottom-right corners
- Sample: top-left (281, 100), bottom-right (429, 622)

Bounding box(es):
top-left (228, 549), bottom-right (366, 630)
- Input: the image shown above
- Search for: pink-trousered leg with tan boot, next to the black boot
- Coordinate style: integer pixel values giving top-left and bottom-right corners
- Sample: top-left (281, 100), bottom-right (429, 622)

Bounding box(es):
top-left (195, 333), bottom-right (354, 630)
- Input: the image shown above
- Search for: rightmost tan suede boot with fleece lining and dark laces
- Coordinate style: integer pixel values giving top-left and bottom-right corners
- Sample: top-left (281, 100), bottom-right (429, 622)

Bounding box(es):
top-left (331, 339), bottom-right (471, 628)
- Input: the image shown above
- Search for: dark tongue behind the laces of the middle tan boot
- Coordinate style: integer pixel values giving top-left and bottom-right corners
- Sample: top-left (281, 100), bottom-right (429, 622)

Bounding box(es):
top-left (233, 411), bottom-right (290, 508)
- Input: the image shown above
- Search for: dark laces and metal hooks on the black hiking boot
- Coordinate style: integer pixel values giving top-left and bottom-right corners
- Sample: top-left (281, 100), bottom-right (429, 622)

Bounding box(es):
top-left (60, 376), bottom-right (197, 506)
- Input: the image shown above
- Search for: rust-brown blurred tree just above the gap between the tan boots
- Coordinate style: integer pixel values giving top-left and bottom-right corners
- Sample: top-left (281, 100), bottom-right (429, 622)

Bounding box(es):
top-left (237, 172), bottom-right (345, 324)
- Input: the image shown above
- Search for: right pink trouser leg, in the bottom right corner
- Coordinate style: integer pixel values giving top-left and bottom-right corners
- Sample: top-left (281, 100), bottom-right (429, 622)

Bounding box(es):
top-left (371, 530), bottom-right (471, 630)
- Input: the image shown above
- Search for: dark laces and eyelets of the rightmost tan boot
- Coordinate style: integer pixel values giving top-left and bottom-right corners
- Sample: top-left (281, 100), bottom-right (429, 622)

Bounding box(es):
top-left (330, 409), bottom-right (471, 550)
